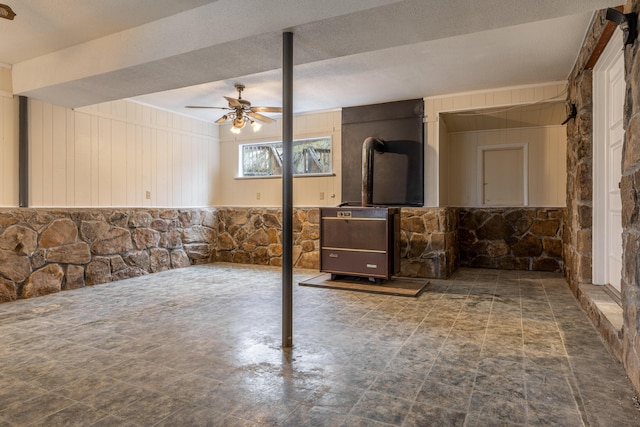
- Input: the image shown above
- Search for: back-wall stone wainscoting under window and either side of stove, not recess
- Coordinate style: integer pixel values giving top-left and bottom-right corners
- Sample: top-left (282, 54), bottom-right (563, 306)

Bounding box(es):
top-left (216, 208), bottom-right (457, 278)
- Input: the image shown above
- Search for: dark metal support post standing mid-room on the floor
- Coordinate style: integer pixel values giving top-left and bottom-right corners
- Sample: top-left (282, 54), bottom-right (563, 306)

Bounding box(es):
top-left (282, 32), bottom-right (293, 348)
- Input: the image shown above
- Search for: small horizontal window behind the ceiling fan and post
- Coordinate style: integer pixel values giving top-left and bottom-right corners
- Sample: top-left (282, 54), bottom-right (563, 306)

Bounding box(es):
top-left (240, 136), bottom-right (333, 177)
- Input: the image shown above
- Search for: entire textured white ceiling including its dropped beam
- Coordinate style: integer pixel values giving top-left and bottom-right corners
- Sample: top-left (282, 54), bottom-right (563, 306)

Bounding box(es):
top-left (0, 0), bottom-right (617, 120)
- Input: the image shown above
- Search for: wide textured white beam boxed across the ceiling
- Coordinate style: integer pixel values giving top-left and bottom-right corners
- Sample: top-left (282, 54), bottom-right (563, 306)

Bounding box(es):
top-left (13, 0), bottom-right (615, 107)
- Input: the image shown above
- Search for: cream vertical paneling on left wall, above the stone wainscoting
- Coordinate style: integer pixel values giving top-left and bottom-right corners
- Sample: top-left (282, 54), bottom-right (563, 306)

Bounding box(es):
top-left (29, 100), bottom-right (219, 207)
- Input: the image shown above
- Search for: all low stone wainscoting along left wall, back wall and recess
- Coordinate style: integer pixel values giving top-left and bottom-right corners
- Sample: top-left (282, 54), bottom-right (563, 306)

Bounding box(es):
top-left (0, 207), bottom-right (562, 302)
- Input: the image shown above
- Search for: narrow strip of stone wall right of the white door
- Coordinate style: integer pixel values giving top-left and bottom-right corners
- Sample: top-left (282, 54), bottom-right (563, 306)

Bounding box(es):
top-left (620, 0), bottom-right (640, 391)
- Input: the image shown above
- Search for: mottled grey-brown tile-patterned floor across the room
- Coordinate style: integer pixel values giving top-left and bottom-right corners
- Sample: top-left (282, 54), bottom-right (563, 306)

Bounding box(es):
top-left (0, 264), bottom-right (640, 427)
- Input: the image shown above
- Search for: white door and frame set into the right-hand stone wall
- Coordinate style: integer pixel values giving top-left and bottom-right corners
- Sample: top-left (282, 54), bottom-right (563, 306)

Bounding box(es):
top-left (593, 28), bottom-right (626, 292)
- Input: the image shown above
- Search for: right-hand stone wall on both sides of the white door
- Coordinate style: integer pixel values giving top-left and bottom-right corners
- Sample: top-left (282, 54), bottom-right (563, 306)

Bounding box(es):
top-left (564, 0), bottom-right (640, 391)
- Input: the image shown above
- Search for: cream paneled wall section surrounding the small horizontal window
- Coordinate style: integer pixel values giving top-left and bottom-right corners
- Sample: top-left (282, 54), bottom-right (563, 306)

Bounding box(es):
top-left (219, 111), bottom-right (342, 207)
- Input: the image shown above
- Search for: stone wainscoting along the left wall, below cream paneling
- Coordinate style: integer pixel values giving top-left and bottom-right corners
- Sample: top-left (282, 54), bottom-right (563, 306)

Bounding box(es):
top-left (0, 209), bottom-right (217, 302)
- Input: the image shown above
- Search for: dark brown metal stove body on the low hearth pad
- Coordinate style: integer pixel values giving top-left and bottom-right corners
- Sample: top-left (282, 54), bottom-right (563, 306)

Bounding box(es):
top-left (320, 207), bottom-right (400, 280)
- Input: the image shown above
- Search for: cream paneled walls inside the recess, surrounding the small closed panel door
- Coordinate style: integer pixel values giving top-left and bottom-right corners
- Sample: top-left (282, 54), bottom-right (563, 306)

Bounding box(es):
top-left (448, 126), bottom-right (567, 207)
